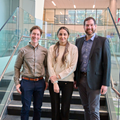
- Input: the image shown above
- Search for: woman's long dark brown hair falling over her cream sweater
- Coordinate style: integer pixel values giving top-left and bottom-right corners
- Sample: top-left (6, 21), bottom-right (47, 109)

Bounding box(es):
top-left (54, 26), bottom-right (70, 65)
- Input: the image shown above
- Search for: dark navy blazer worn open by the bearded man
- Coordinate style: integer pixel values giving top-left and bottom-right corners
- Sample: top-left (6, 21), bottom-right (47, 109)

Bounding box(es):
top-left (74, 35), bottom-right (111, 90)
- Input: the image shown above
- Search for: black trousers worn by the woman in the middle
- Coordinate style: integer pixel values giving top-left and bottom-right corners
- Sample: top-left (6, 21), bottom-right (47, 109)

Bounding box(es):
top-left (49, 81), bottom-right (73, 120)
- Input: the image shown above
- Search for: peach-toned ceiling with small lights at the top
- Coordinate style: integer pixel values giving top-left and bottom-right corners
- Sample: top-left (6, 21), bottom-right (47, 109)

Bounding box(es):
top-left (44, 0), bottom-right (120, 9)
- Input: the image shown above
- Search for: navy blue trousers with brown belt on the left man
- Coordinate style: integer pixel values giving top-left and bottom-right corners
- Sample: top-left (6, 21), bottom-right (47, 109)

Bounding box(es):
top-left (21, 79), bottom-right (45, 120)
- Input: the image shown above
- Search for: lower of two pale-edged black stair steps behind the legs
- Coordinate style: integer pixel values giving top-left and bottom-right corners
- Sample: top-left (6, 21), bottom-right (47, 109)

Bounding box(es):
top-left (8, 100), bottom-right (109, 120)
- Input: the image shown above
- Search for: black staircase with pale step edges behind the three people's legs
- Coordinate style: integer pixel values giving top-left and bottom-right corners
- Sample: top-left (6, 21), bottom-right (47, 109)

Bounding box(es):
top-left (4, 87), bottom-right (109, 120)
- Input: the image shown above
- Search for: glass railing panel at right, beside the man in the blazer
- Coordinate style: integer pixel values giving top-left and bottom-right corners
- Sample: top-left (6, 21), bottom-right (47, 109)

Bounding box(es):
top-left (97, 9), bottom-right (120, 120)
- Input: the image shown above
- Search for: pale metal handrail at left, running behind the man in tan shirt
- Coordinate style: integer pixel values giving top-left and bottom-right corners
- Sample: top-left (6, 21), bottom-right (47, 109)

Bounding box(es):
top-left (0, 36), bottom-right (58, 81)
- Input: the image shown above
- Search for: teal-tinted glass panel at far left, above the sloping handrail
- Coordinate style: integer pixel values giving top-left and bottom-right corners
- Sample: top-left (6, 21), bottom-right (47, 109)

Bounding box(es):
top-left (0, 8), bottom-right (19, 85)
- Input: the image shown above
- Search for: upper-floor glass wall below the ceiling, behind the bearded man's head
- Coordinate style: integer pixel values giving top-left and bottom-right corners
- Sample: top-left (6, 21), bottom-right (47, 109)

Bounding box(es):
top-left (43, 9), bottom-right (107, 25)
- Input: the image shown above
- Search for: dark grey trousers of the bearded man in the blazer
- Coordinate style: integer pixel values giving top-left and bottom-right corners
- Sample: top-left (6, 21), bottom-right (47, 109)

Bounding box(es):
top-left (78, 74), bottom-right (100, 120)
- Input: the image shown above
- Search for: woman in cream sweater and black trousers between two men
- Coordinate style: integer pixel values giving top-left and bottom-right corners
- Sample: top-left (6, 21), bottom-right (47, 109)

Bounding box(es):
top-left (48, 27), bottom-right (78, 120)
